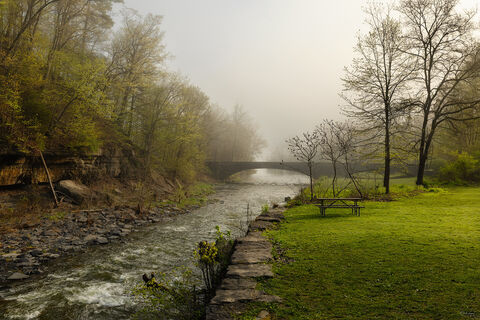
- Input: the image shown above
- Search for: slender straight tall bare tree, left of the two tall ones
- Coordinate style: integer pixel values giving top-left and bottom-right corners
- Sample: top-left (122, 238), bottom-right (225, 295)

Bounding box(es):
top-left (342, 5), bottom-right (415, 193)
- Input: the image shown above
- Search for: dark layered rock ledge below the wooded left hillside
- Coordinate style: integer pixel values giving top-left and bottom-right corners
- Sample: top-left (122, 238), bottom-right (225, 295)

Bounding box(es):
top-left (0, 147), bottom-right (141, 186)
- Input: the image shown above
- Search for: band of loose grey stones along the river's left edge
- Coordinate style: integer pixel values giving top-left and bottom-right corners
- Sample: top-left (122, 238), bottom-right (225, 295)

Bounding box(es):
top-left (0, 205), bottom-right (201, 286)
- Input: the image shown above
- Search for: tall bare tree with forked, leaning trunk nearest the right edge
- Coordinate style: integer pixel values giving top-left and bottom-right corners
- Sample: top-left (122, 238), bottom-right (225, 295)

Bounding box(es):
top-left (398, 0), bottom-right (480, 185)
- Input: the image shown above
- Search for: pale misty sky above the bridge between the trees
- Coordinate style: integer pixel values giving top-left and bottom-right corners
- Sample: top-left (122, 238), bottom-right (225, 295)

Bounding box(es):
top-left (118, 0), bottom-right (478, 158)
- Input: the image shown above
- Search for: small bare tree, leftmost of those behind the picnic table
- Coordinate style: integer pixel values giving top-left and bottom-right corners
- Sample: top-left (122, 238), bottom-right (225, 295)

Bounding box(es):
top-left (286, 130), bottom-right (320, 201)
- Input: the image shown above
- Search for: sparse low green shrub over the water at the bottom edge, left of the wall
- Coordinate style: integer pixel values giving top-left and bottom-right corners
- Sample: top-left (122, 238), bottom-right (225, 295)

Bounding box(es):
top-left (133, 267), bottom-right (204, 320)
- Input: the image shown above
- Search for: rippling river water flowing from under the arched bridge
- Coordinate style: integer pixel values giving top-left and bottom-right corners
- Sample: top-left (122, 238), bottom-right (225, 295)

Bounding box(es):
top-left (0, 169), bottom-right (307, 320)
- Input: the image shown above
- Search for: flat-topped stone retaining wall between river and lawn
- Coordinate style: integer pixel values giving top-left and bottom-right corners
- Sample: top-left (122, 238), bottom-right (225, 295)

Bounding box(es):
top-left (206, 208), bottom-right (284, 320)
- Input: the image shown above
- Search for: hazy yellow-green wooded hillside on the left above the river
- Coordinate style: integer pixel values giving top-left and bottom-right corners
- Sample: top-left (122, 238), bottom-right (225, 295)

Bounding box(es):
top-left (0, 0), bottom-right (263, 180)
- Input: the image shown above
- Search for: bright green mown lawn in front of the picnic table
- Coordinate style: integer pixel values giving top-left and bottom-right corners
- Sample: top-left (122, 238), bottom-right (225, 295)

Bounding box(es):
top-left (244, 188), bottom-right (480, 319)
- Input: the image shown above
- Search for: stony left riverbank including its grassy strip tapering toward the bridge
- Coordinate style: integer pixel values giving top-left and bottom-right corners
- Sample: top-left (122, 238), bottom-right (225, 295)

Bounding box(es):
top-left (0, 180), bottom-right (213, 286)
